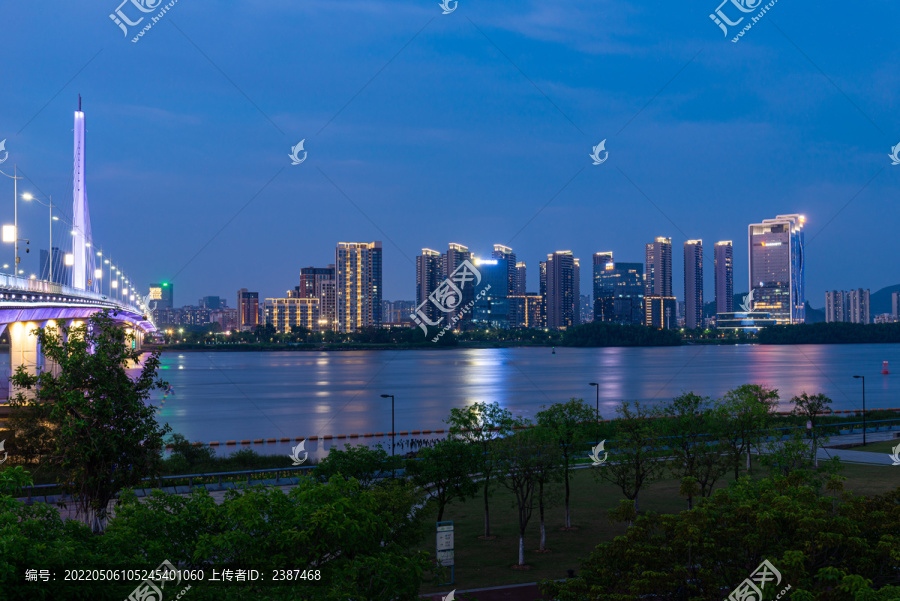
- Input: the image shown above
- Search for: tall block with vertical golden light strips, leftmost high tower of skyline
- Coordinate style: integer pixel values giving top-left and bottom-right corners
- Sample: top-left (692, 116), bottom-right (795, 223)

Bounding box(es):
top-left (334, 240), bottom-right (382, 332)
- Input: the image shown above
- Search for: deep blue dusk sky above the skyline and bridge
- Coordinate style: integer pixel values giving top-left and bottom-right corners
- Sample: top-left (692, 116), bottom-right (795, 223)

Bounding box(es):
top-left (0, 0), bottom-right (900, 307)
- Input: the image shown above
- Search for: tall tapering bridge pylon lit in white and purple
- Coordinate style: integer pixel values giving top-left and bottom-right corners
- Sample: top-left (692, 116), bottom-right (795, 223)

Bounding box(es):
top-left (72, 95), bottom-right (100, 292)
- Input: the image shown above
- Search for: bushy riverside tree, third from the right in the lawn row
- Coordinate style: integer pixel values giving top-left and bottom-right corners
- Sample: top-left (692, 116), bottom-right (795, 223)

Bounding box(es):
top-left (659, 392), bottom-right (729, 509)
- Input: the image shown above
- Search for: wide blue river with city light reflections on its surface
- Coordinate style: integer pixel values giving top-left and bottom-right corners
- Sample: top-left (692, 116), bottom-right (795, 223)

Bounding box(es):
top-left (125, 345), bottom-right (900, 457)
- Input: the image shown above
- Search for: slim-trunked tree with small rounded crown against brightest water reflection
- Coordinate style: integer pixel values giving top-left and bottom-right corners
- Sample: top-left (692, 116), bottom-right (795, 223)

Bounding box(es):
top-left (445, 403), bottom-right (513, 538)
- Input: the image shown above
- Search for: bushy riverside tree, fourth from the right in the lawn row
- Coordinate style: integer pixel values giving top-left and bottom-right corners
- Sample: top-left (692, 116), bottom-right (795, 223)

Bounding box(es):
top-left (594, 401), bottom-right (666, 512)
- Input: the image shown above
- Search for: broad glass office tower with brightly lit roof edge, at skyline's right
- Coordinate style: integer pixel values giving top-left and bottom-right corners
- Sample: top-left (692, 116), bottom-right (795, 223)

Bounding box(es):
top-left (748, 215), bottom-right (806, 325)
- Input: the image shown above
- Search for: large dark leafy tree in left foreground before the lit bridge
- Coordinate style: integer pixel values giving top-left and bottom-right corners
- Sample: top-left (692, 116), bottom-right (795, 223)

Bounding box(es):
top-left (10, 312), bottom-right (171, 531)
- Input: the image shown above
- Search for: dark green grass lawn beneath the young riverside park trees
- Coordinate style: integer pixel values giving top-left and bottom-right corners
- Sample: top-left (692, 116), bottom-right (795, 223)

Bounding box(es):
top-left (419, 462), bottom-right (900, 594)
